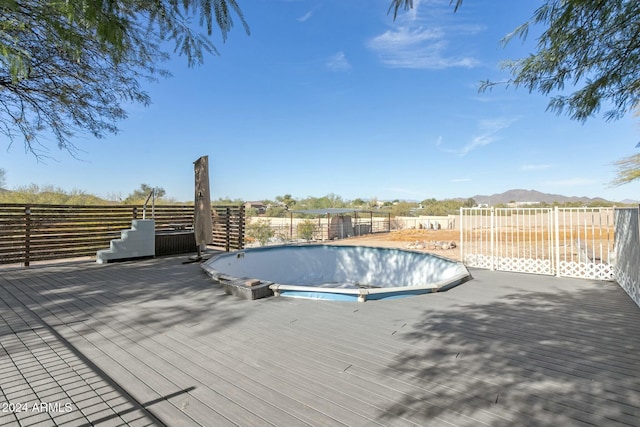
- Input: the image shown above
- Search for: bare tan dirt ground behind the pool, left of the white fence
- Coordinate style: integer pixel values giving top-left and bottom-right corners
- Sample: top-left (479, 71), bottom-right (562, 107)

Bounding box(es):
top-left (331, 230), bottom-right (460, 261)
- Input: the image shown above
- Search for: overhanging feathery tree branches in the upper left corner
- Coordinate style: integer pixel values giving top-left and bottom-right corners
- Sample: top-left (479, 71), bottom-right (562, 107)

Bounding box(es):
top-left (0, 0), bottom-right (249, 156)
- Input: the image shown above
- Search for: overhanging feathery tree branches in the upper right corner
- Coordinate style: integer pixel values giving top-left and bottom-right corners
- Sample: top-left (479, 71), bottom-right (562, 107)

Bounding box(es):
top-left (496, 0), bottom-right (640, 121)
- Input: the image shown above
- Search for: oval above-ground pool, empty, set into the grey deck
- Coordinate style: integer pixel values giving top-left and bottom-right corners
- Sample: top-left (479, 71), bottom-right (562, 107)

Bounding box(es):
top-left (202, 245), bottom-right (470, 301)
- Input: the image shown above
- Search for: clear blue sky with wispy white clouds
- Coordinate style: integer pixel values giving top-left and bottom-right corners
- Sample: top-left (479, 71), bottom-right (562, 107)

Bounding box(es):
top-left (0, 0), bottom-right (640, 201)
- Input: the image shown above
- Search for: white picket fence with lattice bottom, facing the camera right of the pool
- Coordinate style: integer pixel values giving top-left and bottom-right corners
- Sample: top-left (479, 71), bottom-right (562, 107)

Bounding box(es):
top-left (460, 207), bottom-right (614, 280)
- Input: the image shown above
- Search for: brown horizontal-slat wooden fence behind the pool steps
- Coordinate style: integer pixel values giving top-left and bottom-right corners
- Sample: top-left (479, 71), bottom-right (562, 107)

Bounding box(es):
top-left (0, 204), bottom-right (245, 266)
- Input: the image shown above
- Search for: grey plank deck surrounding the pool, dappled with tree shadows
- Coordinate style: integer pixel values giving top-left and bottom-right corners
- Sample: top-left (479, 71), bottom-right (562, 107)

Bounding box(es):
top-left (0, 257), bottom-right (640, 426)
